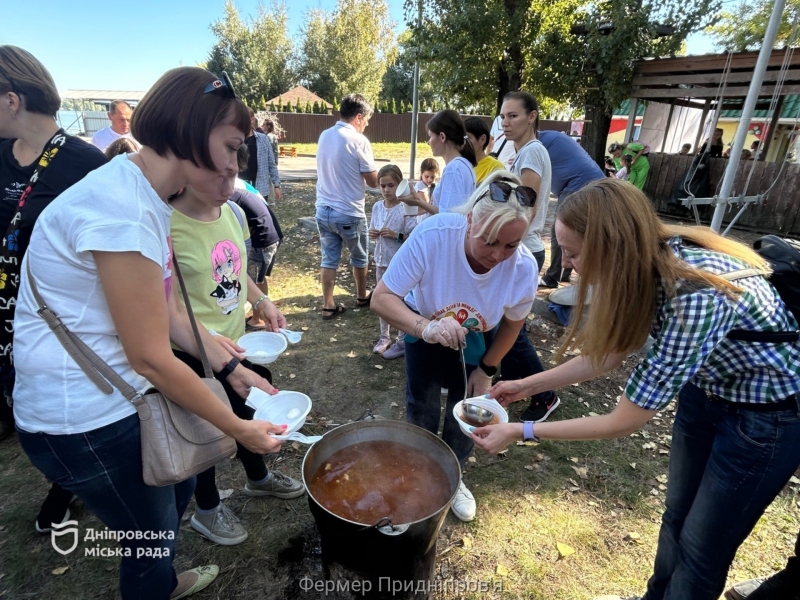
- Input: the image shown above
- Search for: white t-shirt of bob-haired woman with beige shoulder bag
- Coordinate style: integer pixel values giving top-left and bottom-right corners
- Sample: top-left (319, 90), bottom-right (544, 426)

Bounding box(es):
top-left (14, 155), bottom-right (172, 435)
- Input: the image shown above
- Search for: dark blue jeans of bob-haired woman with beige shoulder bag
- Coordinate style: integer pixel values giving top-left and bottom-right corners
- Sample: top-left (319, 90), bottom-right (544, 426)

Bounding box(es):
top-left (17, 414), bottom-right (194, 600)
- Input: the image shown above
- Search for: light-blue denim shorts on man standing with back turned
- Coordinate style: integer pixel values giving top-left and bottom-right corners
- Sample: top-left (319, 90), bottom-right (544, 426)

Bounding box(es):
top-left (316, 206), bottom-right (369, 269)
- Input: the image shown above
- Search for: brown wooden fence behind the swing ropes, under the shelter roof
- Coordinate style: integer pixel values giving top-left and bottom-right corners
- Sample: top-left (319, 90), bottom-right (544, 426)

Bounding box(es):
top-left (644, 152), bottom-right (800, 236)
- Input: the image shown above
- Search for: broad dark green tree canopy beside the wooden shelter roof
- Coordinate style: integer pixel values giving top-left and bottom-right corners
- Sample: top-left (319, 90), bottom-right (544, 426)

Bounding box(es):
top-left (406, 0), bottom-right (720, 159)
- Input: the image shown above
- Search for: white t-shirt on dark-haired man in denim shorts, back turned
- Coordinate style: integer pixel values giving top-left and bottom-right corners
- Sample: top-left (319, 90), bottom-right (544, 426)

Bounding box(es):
top-left (316, 121), bottom-right (377, 219)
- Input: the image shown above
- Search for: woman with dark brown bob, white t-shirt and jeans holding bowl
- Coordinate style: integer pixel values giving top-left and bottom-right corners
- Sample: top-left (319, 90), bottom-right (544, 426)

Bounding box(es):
top-left (14, 67), bottom-right (283, 600)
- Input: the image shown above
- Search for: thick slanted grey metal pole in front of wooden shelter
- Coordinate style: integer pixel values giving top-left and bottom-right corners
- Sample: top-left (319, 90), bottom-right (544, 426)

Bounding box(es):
top-left (711, 0), bottom-right (786, 232)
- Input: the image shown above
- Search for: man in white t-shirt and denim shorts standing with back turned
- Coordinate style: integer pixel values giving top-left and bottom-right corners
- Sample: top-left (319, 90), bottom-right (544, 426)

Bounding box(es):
top-left (316, 94), bottom-right (378, 319)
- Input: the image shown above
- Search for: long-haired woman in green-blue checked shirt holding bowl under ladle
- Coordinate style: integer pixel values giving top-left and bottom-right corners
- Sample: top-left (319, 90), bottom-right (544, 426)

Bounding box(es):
top-left (474, 179), bottom-right (800, 600)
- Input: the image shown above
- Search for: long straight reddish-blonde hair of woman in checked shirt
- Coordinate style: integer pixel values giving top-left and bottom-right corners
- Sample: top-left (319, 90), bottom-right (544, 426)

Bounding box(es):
top-left (556, 178), bottom-right (769, 368)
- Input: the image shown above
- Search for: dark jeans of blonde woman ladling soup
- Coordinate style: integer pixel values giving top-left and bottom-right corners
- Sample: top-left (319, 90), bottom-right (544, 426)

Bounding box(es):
top-left (406, 340), bottom-right (475, 468)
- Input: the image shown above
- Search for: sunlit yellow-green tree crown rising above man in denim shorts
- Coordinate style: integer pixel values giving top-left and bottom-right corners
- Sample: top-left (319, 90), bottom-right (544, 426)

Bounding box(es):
top-left (298, 0), bottom-right (397, 102)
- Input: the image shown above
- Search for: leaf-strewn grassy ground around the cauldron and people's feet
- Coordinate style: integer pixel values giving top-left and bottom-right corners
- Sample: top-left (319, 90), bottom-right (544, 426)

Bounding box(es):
top-left (0, 180), bottom-right (800, 600)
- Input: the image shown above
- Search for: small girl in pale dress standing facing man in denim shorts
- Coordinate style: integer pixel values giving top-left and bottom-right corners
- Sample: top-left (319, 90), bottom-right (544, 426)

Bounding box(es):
top-left (369, 165), bottom-right (417, 360)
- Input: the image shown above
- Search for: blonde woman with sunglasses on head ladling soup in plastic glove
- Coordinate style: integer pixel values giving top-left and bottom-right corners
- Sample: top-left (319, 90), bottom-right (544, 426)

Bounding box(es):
top-left (371, 171), bottom-right (536, 521)
